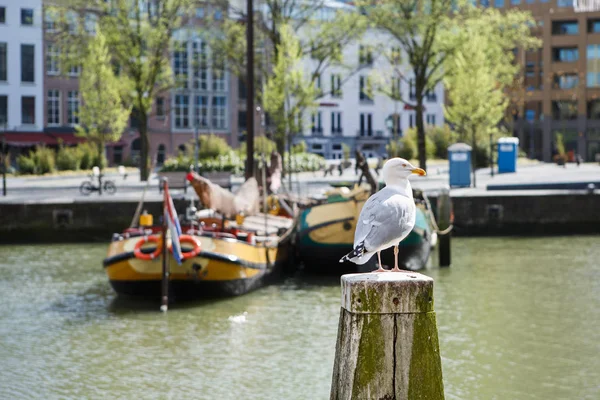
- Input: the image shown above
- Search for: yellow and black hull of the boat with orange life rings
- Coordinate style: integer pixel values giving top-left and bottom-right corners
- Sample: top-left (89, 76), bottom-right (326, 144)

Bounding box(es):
top-left (104, 236), bottom-right (286, 297)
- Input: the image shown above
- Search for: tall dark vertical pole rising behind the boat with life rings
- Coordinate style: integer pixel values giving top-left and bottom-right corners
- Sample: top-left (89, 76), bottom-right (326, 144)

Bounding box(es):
top-left (246, 0), bottom-right (254, 179)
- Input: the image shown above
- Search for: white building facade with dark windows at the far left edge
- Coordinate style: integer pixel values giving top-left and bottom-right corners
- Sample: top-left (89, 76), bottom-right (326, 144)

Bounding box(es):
top-left (0, 0), bottom-right (44, 132)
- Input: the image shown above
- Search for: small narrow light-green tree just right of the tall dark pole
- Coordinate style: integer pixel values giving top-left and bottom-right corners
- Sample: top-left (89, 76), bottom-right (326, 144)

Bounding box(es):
top-left (263, 25), bottom-right (316, 165)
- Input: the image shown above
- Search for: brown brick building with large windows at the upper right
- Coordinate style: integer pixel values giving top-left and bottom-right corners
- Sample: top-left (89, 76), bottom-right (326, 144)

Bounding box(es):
top-left (496, 0), bottom-right (600, 161)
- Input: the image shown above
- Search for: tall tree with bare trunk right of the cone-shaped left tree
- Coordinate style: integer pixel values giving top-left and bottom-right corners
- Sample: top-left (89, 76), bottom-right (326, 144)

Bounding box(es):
top-left (56, 0), bottom-right (193, 180)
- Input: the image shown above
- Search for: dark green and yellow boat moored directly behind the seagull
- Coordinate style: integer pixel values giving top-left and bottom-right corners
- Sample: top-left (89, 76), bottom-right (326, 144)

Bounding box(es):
top-left (297, 185), bottom-right (437, 274)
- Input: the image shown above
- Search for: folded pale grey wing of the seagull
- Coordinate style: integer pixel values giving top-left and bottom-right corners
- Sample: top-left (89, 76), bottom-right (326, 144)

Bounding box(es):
top-left (363, 194), bottom-right (416, 251)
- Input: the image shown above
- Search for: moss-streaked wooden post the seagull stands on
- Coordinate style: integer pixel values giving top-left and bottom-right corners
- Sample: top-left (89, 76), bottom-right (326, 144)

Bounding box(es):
top-left (330, 272), bottom-right (444, 400)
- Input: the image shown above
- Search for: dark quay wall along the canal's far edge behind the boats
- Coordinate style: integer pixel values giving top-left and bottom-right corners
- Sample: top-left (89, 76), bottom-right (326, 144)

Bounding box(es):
top-left (0, 192), bottom-right (600, 243)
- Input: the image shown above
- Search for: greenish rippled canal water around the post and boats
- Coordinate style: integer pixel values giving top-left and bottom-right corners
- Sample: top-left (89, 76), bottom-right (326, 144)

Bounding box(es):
top-left (0, 236), bottom-right (600, 400)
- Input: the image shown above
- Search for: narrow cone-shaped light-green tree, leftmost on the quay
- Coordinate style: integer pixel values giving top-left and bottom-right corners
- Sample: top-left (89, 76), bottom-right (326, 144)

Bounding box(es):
top-left (76, 30), bottom-right (131, 169)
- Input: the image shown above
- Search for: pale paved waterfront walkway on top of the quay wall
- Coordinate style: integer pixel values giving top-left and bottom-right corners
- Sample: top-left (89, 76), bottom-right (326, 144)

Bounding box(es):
top-left (0, 160), bottom-right (600, 203)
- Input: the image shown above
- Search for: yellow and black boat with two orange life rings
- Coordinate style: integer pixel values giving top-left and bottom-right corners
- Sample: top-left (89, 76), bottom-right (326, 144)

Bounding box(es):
top-left (104, 173), bottom-right (295, 298)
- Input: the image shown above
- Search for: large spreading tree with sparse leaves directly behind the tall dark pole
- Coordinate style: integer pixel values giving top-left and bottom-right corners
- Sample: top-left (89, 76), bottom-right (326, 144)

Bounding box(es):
top-left (211, 0), bottom-right (367, 161)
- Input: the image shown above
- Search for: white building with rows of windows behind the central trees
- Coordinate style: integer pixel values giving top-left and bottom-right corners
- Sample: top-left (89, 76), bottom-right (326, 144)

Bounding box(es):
top-left (294, 18), bottom-right (444, 159)
